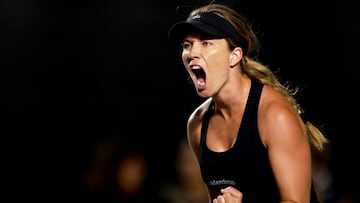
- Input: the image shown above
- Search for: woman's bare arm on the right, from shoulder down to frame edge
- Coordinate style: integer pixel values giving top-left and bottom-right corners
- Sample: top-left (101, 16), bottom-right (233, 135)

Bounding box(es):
top-left (259, 96), bottom-right (311, 202)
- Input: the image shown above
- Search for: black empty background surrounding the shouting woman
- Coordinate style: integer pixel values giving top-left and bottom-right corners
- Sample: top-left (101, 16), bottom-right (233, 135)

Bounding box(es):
top-left (0, 0), bottom-right (360, 202)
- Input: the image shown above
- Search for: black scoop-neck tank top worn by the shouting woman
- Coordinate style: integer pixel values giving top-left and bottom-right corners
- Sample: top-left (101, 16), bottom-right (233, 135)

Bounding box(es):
top-left (199, 81), bottom-right (318, 203)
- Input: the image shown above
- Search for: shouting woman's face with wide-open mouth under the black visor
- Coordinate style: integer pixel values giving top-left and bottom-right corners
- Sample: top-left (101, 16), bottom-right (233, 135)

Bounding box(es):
top-left (182, 33), bottom-right (231, 98)
